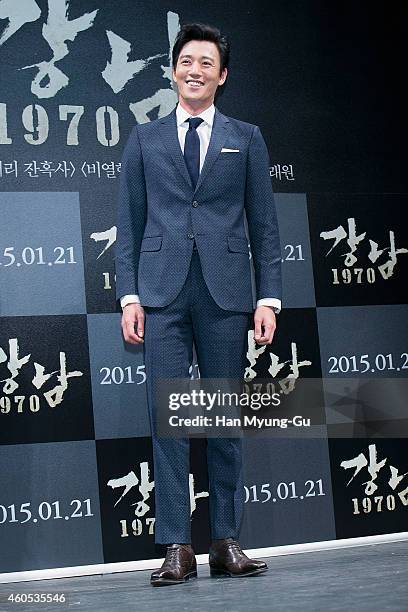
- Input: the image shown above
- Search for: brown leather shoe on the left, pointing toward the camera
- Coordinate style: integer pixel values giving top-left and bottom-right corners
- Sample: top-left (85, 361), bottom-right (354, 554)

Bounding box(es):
top-left (150, 544), bottom-right (197, 586)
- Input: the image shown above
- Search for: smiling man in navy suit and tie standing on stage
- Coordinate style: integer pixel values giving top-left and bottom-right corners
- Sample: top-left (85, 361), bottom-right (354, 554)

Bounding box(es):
top-left (116, 24), bottom-right (281, 586)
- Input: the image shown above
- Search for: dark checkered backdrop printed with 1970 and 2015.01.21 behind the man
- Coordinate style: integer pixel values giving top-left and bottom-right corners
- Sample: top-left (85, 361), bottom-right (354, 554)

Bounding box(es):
top-left (0, 0), bottom-right (408, 573)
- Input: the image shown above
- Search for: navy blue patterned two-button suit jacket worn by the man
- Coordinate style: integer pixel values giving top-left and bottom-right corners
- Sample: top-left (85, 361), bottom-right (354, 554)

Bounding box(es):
top-left (115, 109), bottom-right (281, 312)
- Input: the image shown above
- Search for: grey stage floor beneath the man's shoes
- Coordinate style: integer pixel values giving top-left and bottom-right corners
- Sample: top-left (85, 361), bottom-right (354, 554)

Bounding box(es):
top-left (0, 541), bottom-right (408, 612)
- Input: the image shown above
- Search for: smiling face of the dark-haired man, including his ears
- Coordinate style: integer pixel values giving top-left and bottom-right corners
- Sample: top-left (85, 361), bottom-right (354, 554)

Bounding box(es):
top-left (173, 40), bottom-right (227, 107)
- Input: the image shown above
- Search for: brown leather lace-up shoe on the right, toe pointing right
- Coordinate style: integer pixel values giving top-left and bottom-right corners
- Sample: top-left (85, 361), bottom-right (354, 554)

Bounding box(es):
top-left (209, 538), bottom-right (268, 578)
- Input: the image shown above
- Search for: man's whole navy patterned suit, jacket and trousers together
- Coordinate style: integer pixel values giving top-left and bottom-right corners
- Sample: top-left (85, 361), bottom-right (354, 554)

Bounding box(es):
top-left (116, 109), bottom-right (281, 544)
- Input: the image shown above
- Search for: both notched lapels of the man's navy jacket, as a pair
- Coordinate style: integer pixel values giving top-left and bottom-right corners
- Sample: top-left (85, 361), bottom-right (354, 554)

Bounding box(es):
top-left (160, 108), bottom-right (229, 193)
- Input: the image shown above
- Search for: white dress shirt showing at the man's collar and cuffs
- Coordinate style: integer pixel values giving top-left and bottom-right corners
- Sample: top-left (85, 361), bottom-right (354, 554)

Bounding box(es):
top-left (120, 104), bottom-right (282, 313)
